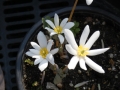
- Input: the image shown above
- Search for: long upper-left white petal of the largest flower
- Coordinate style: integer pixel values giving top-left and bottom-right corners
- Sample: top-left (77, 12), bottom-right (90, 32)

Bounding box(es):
top-left (64, 29), bottom-right (78, 50)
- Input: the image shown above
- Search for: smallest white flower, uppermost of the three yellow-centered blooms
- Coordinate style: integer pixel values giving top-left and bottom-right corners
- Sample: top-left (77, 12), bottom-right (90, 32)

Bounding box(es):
top-left (45, 14), bottom-right (74, 44)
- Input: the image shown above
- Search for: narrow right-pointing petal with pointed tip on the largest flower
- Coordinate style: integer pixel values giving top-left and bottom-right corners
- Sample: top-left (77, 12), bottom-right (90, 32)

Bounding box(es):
top-left (87, 48), bottom-right (110, 56)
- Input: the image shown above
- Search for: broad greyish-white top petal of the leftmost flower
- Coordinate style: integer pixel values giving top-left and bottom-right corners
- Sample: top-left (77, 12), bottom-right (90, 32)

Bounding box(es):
top-left (37, 31), bottom-right (47, 48)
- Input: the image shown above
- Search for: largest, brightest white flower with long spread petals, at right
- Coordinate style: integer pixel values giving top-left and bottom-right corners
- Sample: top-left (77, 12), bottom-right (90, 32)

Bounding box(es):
top-left (64, 25), bottom-right (109, 73)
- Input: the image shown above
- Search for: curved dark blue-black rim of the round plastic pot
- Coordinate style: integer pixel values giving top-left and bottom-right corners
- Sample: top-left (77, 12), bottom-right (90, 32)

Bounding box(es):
top-left (16, 6), bottom-right (120, 90)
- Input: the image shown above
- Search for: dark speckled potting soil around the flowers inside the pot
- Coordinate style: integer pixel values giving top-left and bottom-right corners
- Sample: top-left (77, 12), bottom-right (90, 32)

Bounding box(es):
top-left (23, 13), bottom-right (120, 90)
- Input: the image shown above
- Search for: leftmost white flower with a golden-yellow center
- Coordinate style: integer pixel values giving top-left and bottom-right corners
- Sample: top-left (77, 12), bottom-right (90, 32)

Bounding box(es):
top-left (26, 31), bottom-right (58, 71)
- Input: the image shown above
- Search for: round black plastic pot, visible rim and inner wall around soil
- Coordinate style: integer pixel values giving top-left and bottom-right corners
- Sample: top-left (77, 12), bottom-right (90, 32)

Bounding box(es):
top-left (16, 6), bottom-right (120, 90)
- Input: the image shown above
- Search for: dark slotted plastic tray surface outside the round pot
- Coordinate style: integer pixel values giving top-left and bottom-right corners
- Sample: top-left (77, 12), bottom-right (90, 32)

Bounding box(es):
top-left (0, 0), bottom-right (120, 90)
